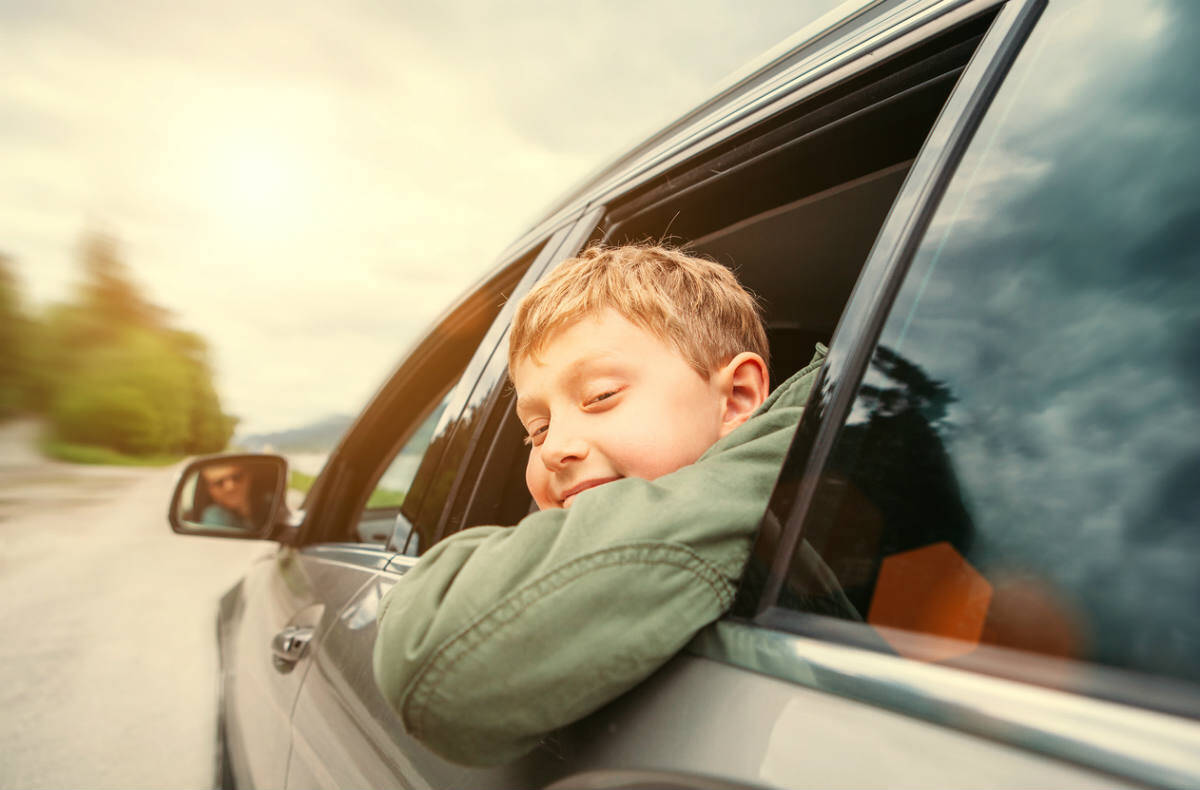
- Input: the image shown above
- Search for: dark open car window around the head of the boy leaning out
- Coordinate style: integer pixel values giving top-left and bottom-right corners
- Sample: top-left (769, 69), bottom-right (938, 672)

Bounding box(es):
top-left (464, 17), bottom-right (990, 525)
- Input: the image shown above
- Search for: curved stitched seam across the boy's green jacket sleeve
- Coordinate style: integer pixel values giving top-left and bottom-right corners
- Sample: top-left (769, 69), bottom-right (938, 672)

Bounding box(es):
top-left (406, 543), bottom-right (733, 735)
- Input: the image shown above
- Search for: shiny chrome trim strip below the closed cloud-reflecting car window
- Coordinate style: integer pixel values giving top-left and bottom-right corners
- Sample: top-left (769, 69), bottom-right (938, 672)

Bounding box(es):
top-left (686, 611), bottom-right (1200, 789)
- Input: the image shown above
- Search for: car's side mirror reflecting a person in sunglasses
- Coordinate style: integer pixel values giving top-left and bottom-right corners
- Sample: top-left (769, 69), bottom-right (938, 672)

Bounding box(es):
top-left (167, 455), bottom-right (288, 539)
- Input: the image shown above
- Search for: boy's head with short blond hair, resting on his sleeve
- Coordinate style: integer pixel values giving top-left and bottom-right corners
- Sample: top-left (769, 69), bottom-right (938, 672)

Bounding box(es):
top-left (509, 246), bottom-right (768, 509)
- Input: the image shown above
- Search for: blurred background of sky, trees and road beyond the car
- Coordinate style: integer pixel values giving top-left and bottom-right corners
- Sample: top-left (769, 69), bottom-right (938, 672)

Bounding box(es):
top-left (0, 0), bottom-right (838, 786)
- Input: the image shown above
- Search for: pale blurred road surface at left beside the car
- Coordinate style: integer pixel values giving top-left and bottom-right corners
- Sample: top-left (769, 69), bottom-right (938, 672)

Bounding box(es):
top-left (0, 421), bottom-right (274, 788)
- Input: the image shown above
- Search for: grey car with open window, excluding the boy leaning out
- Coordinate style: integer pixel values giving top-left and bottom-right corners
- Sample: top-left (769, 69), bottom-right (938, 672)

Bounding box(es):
top-left (170, 0), bottom-right (1200, 789)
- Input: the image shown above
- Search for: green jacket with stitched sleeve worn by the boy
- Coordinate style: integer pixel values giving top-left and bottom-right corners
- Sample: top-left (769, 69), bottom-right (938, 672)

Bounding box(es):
top-left (374, 346), bottom-right (826, 765)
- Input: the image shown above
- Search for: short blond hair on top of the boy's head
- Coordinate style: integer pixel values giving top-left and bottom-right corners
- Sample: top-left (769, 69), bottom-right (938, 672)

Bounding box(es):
top-left (509, 245), bottom-right (769, 378)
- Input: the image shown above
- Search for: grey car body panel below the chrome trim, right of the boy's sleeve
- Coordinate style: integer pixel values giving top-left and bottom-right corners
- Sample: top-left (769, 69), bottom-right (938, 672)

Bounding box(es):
top-left (560, 650), bottom-right (1138, 788)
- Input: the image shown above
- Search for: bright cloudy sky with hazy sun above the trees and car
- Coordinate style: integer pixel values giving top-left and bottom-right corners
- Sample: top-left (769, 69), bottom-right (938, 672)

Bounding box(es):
top-left (0, 0), bottom-right (839, 435)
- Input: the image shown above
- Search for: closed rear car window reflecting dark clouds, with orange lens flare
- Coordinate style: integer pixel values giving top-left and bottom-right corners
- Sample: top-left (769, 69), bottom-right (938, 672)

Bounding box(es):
top-left (776, 1), bottom-right (1200, 716)
